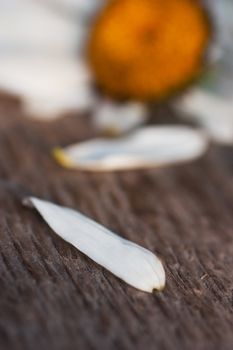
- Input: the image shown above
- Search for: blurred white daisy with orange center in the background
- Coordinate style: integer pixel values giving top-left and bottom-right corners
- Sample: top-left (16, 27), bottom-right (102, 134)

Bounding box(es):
top-left (0, 0), bottom-right (233, 142)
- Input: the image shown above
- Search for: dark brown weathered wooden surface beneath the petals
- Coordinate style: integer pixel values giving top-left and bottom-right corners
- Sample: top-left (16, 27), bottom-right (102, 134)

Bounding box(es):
top-left (0, 93), bottom-right (233, 350)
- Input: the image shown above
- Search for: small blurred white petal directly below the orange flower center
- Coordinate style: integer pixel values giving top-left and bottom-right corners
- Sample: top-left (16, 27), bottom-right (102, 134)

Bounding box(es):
top-left (93, 100), bottom-right (147, 135)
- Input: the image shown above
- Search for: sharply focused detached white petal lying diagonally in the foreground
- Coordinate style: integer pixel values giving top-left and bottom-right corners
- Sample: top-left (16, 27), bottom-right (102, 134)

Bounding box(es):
top-left (25, 197), bottom-right (165, 292)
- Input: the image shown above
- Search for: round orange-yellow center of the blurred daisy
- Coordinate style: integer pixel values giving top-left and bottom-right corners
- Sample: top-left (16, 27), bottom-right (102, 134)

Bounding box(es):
top-left (87, 0), bottom-right (210, 100)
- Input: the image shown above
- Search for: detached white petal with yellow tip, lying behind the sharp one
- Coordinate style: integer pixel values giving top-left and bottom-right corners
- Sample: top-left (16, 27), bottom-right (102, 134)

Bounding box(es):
top-left (54, 126), bottom-right (208, 171)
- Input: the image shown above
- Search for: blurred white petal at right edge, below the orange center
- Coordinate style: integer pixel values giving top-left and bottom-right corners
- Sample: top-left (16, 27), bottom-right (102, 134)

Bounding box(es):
top-left (176, 89), bottom-right (233, 144)
